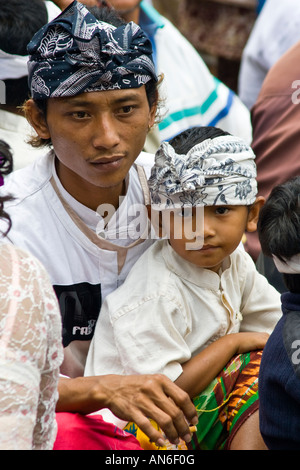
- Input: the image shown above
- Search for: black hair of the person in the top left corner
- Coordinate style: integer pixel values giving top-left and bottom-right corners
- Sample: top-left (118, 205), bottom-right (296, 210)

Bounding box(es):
top-left (0, 0), bottom-right (48, 107)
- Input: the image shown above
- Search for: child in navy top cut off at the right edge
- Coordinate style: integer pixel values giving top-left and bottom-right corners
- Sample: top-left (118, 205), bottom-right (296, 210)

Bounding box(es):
top-left (258, 177), bottom-right (300, 450)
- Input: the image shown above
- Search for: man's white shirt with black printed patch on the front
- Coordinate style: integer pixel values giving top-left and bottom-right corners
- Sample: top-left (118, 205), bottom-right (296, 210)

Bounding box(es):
top-left (0, 152), bottom-right (153, 377)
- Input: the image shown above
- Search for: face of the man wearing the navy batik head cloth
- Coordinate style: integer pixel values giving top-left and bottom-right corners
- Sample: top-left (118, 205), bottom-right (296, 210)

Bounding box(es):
top-left (33, 86), bottom-right (155, 207)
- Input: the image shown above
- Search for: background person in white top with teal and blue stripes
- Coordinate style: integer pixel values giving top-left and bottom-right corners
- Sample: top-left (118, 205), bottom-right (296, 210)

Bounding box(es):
top-left (55, 0), bottom-right (252, 152)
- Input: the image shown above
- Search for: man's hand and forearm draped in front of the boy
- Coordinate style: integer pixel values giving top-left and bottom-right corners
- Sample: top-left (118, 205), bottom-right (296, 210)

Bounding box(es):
top-left (57, 374), bottom-right (198, 446)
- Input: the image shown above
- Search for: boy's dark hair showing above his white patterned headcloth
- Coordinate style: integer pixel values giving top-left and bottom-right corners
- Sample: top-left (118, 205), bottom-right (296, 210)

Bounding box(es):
top-left (170, 126), bottom-right (230, 155)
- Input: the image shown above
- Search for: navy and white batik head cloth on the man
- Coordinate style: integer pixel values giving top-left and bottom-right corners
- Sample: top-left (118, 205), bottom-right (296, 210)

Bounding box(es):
top-left (28, 1), bottom-right (157, 99)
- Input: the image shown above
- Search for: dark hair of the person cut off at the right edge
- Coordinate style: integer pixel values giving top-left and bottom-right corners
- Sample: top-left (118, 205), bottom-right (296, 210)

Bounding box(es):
top-left (257, 176), bottom-right (300, 293)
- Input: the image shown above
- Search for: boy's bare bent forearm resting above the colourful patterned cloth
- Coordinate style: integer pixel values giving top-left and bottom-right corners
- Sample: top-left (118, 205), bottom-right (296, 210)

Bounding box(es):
top-left (175, 333), bottom-right (269, 397)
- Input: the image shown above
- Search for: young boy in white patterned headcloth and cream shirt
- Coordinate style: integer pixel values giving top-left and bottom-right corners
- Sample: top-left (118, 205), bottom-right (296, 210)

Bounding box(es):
top-left (85, 127), bottom-right (280, 449)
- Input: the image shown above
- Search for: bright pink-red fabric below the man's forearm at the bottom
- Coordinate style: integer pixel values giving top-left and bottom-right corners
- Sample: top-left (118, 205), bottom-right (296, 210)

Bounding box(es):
top-left (53, 413), bottom-right (142, 450)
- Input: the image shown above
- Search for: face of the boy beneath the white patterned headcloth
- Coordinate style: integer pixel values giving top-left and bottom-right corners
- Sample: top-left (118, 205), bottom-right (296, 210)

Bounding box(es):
top-left (167, 206), bottom-right (255, 272)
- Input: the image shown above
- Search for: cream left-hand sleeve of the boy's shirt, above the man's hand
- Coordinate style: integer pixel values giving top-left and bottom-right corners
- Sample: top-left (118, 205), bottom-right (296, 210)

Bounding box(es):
top-left (85, 291), bottom-right (191, 381)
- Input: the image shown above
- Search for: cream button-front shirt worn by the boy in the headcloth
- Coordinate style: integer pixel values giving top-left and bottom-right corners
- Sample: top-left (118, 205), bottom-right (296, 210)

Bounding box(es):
top-left (85, 240), bottom-right (281, 426)
